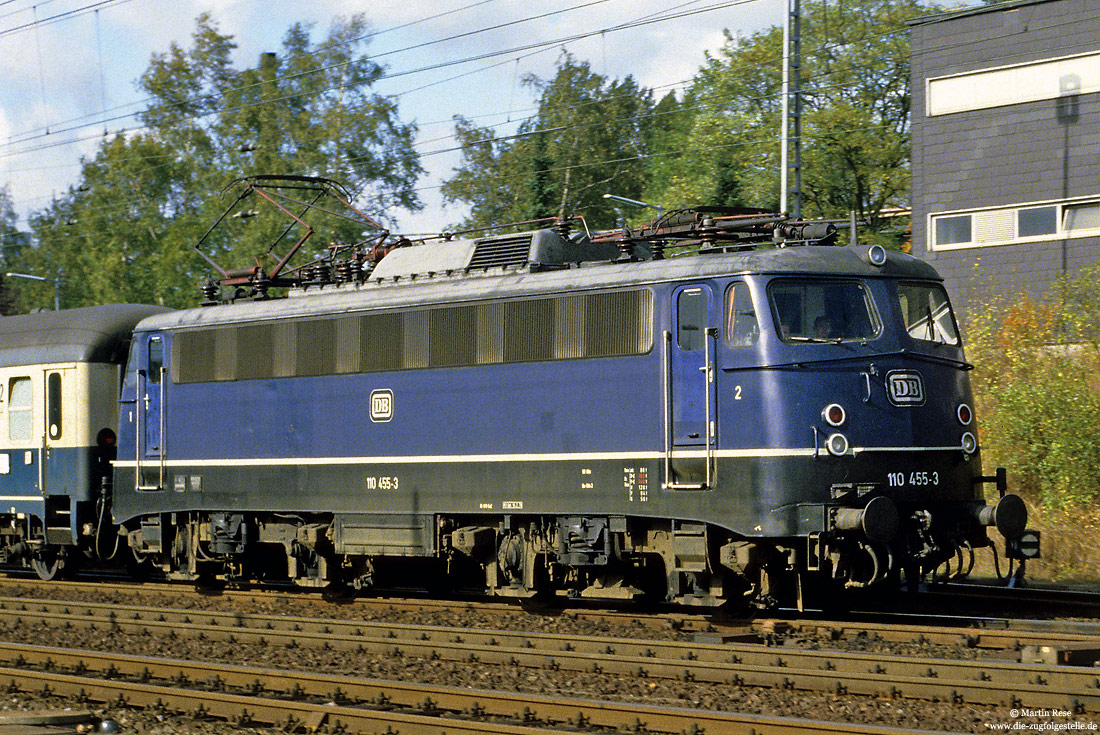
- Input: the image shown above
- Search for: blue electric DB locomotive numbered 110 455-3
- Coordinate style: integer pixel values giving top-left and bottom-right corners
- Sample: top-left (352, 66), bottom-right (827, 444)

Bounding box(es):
top-left (101, 182), bottom-right (1026, 605)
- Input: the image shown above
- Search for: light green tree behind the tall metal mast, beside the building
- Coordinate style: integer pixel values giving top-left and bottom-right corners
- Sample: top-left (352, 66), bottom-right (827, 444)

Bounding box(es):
top-left (646, 0), bottom-right (939, 242)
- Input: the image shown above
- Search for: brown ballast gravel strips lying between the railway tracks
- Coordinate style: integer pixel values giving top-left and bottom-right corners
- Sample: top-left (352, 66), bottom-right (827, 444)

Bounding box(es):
top-left (0, 580), bottom-right (1086, 735)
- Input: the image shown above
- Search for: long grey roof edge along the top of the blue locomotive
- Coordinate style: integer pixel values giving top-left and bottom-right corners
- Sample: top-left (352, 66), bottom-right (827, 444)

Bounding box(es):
top-left (138, 245), bottom-right (942, 331)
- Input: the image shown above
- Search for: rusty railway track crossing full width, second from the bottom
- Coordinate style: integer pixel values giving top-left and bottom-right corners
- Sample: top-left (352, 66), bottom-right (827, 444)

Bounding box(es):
top-left (0, 599), bottom-right (1100, 713)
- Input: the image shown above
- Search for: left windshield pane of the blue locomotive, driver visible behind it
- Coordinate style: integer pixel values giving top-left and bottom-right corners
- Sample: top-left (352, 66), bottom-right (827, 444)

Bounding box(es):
top-left (768, 279), bottom-right (882, 342)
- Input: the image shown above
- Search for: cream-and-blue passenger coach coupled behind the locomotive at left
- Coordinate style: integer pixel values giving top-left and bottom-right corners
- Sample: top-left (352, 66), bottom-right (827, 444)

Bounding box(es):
top-left (0, 304), bottom-right (164, 579)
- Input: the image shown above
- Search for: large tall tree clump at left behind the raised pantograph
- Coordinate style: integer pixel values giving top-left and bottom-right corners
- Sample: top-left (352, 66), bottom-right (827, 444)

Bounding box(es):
top-left (25, 14), bottom-right (421, 306)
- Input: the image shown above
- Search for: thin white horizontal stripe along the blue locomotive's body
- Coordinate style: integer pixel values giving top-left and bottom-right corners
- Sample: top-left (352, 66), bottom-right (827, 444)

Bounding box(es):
top-left (114, 446), bottom-right (960, 469)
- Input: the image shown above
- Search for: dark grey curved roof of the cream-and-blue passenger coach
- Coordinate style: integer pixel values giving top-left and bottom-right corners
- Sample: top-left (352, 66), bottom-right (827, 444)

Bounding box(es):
top-left (0, 304), bottom-right (168, 368)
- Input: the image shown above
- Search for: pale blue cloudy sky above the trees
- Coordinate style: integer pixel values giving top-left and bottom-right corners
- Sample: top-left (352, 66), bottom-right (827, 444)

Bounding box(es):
top-left (0, 0), bottom-right (787, 232)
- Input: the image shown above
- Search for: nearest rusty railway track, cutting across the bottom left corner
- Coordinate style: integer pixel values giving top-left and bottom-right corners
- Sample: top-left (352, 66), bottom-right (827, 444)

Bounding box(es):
top-left (0, 645), bottom-right (963, 735)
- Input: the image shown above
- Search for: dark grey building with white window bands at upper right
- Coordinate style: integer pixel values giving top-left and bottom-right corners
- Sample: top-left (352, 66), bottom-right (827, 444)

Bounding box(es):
top-left (911, 0), bottom-right (1100, 321)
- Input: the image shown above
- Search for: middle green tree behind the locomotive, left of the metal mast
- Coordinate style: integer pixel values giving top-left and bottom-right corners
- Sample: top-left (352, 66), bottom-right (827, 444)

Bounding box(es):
top-left (442, 54), bottom-right (653, 228)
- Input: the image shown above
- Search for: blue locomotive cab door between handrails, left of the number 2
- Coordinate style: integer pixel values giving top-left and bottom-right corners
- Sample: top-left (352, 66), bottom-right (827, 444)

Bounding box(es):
top-left (664, 285), bottom-right (717, 490)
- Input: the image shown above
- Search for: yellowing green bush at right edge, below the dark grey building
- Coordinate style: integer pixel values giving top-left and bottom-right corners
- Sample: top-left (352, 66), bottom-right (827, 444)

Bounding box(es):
top-left (968, 266), bottom-right (1100, 512)
